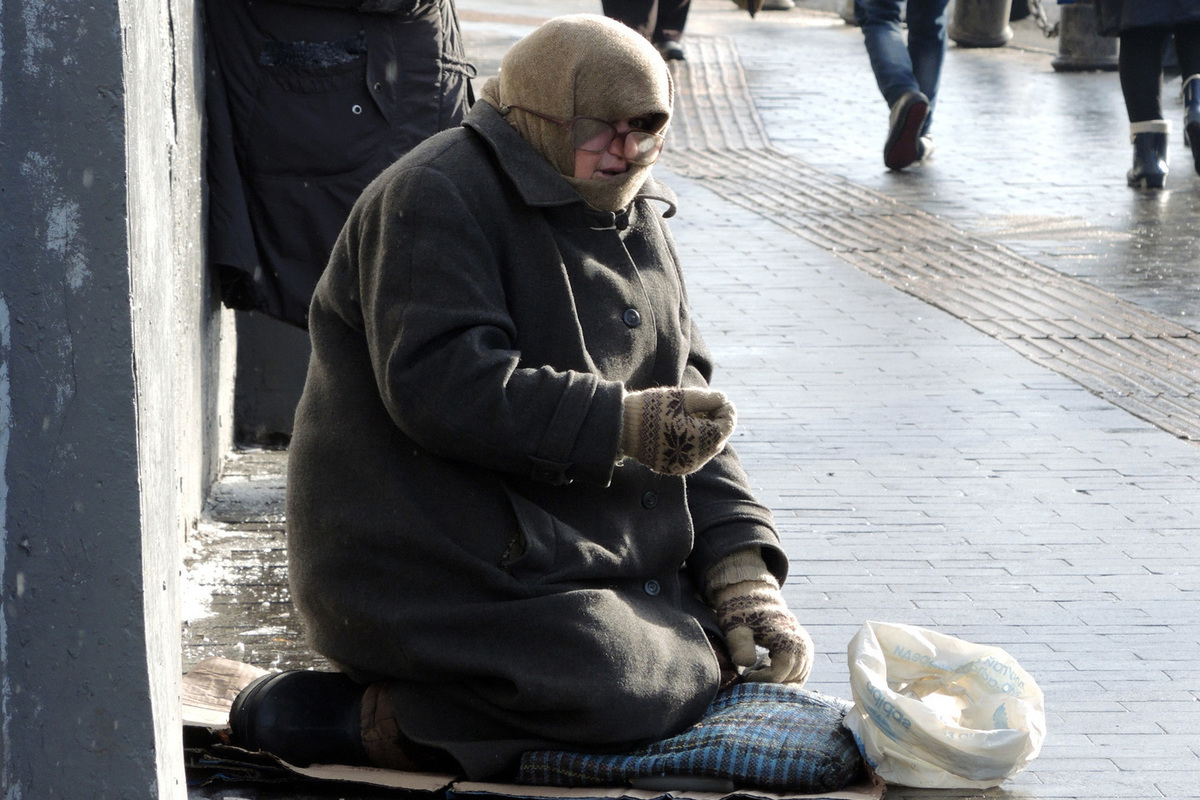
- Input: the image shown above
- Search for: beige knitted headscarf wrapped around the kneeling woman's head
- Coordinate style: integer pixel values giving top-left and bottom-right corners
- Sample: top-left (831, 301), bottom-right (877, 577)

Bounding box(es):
top-left (481, 14), bottom-right (674, 211)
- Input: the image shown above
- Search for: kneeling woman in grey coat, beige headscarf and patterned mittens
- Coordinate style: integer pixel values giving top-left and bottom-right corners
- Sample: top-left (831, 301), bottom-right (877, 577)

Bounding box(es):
top-left (232, 16), bottom-right (812, 780)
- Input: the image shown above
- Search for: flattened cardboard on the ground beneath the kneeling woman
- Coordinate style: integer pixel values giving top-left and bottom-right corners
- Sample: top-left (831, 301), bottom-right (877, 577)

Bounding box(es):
top-left (182, 658), bottom-right (884, 800)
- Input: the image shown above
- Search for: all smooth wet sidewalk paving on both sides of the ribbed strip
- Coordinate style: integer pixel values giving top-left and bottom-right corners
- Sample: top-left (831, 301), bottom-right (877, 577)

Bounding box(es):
top-left (184, 0), bottom-right (1200, 800)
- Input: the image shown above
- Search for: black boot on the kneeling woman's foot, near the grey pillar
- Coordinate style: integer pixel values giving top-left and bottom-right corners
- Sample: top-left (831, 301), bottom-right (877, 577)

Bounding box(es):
top-left (229, 669), bottom-right (371, 766)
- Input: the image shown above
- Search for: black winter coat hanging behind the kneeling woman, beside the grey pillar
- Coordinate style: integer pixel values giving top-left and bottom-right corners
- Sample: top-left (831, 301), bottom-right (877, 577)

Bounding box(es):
top-left (205, 0), bottom-right (473, 327)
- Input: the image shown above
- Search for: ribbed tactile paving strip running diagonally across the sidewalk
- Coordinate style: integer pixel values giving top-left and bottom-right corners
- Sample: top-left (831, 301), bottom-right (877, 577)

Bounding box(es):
top-left (664, 36), bottom-right (1200, 440)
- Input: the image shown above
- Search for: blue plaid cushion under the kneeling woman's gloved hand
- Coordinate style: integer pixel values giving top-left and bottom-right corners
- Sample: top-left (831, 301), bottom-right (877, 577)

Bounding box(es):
top-left (518, 684), bottom-right (864, 794)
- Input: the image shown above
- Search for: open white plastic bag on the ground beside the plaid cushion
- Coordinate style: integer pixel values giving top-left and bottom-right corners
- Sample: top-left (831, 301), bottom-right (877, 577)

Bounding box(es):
top-left (845, 622), bottom-right (1045, 789)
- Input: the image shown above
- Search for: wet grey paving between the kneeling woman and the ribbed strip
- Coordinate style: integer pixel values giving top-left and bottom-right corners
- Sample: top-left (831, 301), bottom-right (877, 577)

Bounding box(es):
top-left (676, 170), bottom-right (1200, 799)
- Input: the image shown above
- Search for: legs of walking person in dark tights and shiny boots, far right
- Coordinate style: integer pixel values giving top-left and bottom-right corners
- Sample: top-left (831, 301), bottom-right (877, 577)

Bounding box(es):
top-left (1097, 0), bottom-right (1200, 190)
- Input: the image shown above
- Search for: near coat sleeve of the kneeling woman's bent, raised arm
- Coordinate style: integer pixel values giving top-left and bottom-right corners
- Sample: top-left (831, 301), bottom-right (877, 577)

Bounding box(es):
top-left (340, 161), bottom-right (623, 485)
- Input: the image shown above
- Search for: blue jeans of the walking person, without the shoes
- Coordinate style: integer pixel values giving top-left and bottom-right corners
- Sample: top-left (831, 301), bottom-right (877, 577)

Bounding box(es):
top-left (854, 0), bottom-right (949, 133)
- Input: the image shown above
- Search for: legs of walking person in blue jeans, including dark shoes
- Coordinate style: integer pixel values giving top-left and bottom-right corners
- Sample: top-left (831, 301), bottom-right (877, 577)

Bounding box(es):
top-left (854, 0), bottom-right (948, 169)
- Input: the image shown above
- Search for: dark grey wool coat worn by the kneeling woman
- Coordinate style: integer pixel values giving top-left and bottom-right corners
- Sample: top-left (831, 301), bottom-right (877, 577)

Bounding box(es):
top-left (287, 103), bottom-right (787, 778)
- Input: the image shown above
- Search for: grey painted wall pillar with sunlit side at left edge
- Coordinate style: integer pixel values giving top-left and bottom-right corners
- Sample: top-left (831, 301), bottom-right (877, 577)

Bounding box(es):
top-left (0, 0), bottom-right (223, 800)
